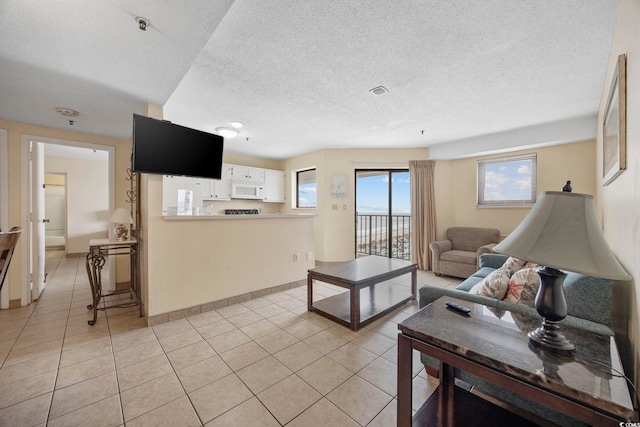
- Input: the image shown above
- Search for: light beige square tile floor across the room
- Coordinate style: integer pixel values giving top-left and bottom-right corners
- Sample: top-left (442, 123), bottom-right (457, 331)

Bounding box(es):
top-left (0, 251), bottom-right (459, 427)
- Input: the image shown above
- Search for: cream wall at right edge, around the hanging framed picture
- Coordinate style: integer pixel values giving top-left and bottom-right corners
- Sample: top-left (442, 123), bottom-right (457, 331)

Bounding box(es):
top-left (596, 0), bottom-right (640, 384)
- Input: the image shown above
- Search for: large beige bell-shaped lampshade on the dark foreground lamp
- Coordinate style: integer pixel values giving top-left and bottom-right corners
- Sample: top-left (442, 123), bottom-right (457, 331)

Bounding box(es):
top-left (493, 191), bottom-right (631, 280)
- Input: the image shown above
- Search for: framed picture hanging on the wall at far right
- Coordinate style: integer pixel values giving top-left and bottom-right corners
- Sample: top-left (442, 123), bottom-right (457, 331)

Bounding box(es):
top-left (602, 54), bottom-right (627, 186)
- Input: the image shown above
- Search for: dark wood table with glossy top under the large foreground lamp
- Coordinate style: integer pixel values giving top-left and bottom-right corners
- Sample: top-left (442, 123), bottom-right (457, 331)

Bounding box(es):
top-left (398, 297), bottom-right (637, 426)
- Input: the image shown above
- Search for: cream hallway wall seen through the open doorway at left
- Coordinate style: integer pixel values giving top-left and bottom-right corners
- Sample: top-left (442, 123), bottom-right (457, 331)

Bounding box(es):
top-left (44, 156), bottom-right (109, 254)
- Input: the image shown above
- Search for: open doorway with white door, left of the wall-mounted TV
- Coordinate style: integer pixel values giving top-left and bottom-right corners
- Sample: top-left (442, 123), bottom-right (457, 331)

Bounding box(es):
top-left (21, 135), bottom-right (115, 305)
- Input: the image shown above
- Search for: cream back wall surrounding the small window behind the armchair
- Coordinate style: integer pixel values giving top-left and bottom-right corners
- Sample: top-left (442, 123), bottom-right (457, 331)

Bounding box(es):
top-left (435, 141), bottom-right (596, 239)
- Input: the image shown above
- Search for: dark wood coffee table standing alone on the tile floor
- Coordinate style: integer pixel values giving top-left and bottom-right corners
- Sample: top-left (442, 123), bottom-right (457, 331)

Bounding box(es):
top-left (307, 255), bottom-right (417, 331)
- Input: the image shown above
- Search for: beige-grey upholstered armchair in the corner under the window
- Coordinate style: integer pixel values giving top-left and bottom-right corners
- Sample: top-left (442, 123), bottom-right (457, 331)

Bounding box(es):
top-left (429, 227), bottom-right (500, 279)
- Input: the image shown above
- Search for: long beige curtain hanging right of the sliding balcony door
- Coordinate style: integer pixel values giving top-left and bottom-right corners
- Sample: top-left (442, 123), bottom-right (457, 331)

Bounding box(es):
top-left (409, 160), bottom-right (436, 270)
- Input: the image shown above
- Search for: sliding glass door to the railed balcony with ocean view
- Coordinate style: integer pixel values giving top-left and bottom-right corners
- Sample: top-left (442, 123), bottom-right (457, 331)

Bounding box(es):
top-left (355, 169), bottom-right (411, 260)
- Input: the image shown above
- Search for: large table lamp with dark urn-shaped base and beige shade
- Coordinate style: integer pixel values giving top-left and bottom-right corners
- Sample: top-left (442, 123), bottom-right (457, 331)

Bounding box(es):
top-left (493, 191), bottom-right (631, 355)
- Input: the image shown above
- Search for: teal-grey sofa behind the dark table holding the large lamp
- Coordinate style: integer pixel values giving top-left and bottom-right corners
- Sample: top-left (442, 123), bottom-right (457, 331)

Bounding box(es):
top-left (419, 253), bottom-right (614, 426)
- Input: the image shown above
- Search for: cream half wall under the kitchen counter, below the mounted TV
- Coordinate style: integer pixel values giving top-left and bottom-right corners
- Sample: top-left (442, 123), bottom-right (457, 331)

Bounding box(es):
top-left (142, 175), bottom-right (314, 316)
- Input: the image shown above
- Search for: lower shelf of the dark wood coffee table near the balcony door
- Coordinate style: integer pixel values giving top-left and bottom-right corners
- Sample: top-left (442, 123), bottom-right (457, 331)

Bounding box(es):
top-left (311, 282), bottom-right (413, 327)
